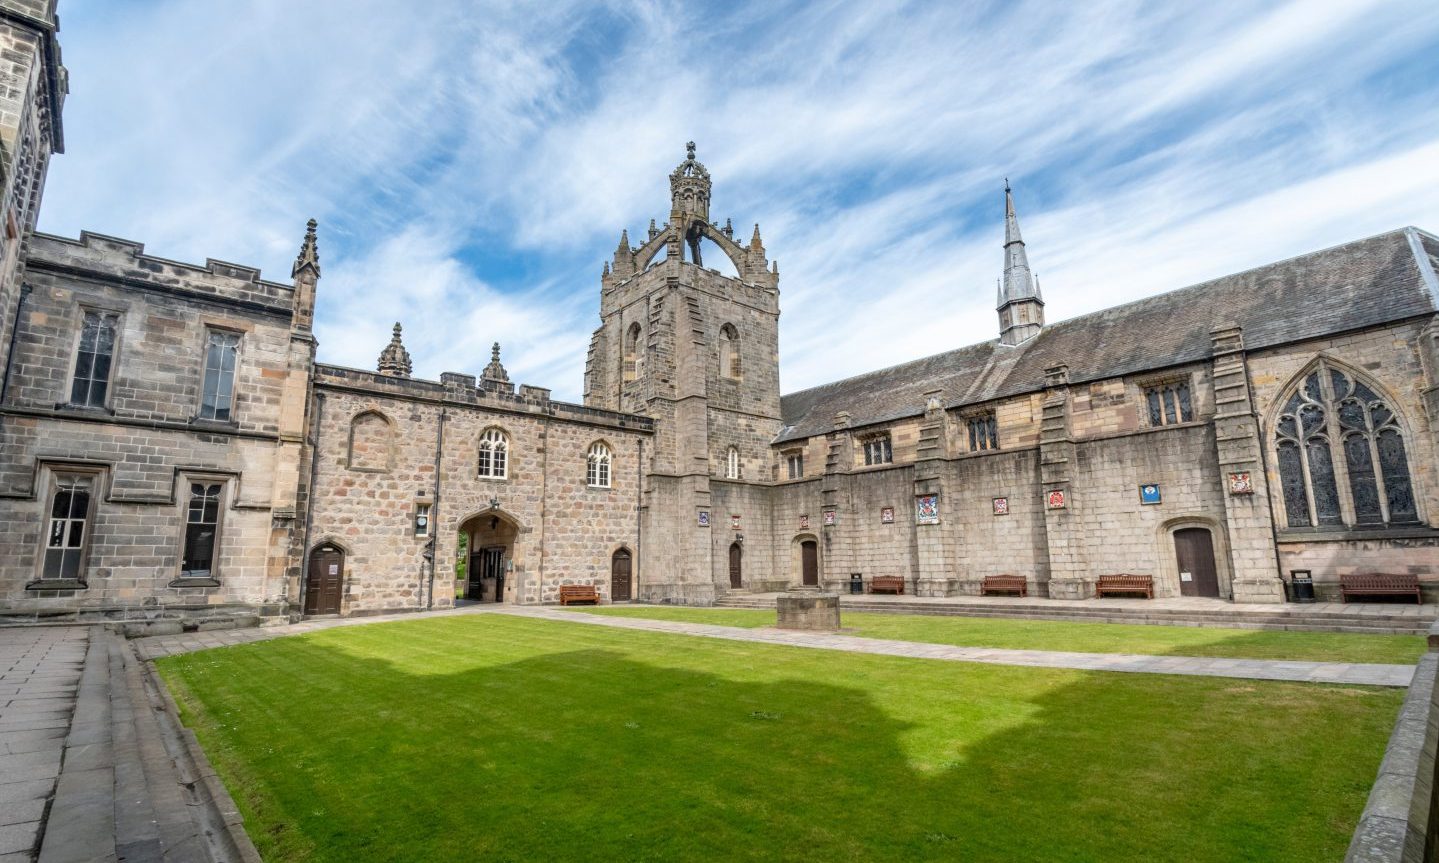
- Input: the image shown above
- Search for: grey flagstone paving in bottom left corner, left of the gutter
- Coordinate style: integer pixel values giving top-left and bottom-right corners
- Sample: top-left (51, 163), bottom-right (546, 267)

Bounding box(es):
top-left (0, 627), bottom-right (89, 863)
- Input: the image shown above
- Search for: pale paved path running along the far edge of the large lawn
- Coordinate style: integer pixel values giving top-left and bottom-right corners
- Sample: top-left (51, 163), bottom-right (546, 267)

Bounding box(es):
top-left (135, 606), bottom-right (1415, 686)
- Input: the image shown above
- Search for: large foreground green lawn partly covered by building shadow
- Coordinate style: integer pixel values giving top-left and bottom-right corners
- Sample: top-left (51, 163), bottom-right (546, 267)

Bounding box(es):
top-left (158, 614), bottom-right (1403, 863)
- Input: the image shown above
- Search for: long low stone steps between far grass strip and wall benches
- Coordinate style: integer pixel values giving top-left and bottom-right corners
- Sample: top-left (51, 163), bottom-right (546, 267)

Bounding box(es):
top-left (715, 595), bottom-right (1432, 634)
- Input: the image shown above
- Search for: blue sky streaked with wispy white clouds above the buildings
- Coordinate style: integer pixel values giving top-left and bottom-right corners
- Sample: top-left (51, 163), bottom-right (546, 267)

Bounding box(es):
top-left (30, 0), bottom-right (1439, 400)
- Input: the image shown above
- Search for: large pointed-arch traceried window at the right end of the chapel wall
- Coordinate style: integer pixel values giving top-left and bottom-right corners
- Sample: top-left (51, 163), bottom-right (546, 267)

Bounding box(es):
top-left (1275, 361), bottom-right (1419, 528)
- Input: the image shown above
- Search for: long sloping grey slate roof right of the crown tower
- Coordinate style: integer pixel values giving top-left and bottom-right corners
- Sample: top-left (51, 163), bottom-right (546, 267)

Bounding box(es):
top-left (776, 227), bottom-right (1439, 443)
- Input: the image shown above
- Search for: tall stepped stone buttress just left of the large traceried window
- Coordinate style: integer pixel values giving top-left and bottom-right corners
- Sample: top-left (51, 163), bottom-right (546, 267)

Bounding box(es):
top-left (1209, 324), bottom-right (1284, 603)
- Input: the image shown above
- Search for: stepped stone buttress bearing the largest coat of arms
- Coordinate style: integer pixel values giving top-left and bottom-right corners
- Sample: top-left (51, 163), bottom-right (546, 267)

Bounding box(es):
top-left (909, 391), bottom-right (960, 597)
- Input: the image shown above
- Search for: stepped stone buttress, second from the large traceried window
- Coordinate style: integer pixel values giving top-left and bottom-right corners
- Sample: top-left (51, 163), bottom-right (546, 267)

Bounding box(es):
top-left (1036, 365), bottom-right (1087, 600)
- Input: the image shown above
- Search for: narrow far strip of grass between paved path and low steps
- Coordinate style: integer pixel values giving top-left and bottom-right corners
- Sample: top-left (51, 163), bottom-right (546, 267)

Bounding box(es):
top-left (567, 606), bottom-right (1425, 665)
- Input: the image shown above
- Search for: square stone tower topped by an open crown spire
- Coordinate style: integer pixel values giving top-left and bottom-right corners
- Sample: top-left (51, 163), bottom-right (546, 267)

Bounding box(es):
top-left (584, 142), bottom-right (780, 603)
